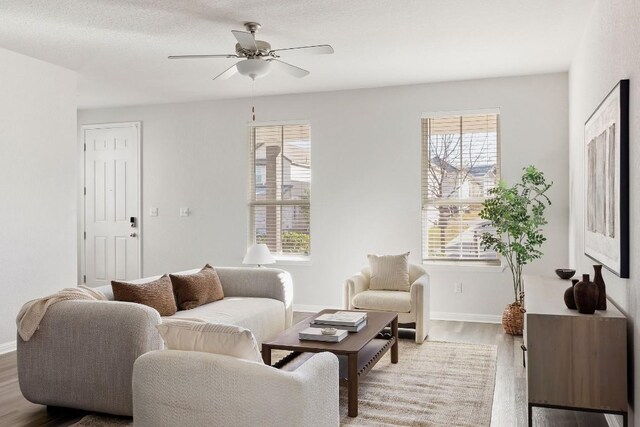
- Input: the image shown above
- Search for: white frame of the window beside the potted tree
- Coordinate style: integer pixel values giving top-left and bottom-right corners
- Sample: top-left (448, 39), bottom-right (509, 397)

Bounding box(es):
top-left (420, 108), bottom-right (505, 272)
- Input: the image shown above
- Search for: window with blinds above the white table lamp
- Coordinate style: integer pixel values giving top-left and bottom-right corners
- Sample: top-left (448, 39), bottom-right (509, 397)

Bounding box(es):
top-left (249, 124), bottom-right (311, 257)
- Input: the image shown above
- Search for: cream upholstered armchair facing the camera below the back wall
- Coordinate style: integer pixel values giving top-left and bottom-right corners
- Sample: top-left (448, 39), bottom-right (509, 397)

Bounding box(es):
top-left (344, 264), bottom-right (430, 344)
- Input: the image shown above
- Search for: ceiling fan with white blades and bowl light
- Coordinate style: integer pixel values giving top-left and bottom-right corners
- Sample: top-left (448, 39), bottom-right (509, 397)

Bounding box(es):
top-left (169, 22), bottom-right (333, 80)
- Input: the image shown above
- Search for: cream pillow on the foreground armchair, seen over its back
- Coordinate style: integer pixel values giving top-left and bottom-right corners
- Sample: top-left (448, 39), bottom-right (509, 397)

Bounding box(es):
top-left (156, 319), bottom-right (263, 363)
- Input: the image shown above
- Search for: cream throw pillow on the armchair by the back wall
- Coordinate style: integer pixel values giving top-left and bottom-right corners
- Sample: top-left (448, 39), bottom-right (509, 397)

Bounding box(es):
top-left (367, 252), bottom-right (411, 291)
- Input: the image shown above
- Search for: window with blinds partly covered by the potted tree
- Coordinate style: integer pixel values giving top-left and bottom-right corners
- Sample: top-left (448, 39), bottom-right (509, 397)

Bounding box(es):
top-left (422, 111), bottom-right (500, 264)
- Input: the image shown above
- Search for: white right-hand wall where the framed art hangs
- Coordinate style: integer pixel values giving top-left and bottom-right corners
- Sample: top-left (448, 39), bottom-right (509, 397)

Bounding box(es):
top-left (569, 0), bottom-right (640, 425)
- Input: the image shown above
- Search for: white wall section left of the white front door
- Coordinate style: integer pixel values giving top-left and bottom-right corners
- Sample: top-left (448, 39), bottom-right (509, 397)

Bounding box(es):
top-left (0, 49), bottom-right (77, 350)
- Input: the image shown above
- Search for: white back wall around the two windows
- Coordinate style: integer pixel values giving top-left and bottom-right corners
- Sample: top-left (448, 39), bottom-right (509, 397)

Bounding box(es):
top-left (78, 73), bottom-right (568, 319)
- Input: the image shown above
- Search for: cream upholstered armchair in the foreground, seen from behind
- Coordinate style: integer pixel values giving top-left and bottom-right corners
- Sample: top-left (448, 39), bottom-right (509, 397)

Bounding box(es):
top-left (133, 350), bottom-right (340, 427)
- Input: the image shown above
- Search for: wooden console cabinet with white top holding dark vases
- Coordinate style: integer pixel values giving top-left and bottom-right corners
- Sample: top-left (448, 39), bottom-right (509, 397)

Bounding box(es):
top-left (523, 276), bottom-right (628, 426)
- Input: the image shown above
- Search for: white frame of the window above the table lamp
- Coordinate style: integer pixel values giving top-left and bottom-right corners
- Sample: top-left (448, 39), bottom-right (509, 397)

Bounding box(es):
top-left (247, 120), bottom-right (313, 265)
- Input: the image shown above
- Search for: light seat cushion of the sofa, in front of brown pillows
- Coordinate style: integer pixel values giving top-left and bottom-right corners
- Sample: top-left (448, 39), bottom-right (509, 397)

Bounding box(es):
top-left (171, 297), bottom-right (285, 344)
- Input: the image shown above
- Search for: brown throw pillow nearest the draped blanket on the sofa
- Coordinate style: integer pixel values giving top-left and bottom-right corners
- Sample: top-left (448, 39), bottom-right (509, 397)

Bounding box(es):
top-left (111, 274), bottom-right (178, 316)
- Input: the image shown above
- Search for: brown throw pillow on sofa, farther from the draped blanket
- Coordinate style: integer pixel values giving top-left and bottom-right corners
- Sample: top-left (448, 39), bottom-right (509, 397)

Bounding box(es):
top-left (169, 264), bottom-right (224, 310)
